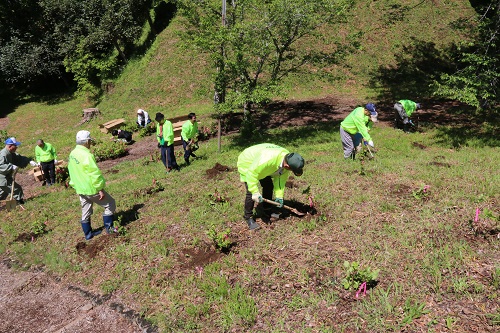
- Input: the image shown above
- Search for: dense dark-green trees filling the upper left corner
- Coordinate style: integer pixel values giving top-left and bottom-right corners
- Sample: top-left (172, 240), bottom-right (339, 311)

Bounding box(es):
top-left (0, 0), bottom-right (158, 97)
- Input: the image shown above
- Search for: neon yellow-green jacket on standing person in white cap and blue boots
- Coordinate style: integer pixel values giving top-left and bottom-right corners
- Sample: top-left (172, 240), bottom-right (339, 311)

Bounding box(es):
top-left (68, 145), bottom-right (106, 195)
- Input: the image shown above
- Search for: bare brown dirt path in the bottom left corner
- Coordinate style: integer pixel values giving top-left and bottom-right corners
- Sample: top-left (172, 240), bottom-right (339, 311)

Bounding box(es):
top-left (0, 259), bottom-right (157, 333)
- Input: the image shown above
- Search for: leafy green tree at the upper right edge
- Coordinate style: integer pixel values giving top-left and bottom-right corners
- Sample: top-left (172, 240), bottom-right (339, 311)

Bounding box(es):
top-left (434, 0), bottom-right (500, 115)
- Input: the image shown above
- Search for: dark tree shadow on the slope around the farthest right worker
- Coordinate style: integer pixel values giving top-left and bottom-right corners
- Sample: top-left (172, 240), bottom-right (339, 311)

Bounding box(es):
top-left (370, 40), bottom-right (500, 148)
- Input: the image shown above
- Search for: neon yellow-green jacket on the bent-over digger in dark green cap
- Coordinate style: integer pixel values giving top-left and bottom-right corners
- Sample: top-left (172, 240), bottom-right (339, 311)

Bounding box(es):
top-left (237, 143), bottom-right (290, 198)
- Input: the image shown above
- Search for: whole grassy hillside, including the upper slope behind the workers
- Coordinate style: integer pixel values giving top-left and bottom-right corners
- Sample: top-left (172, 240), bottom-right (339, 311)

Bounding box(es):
top-left (0, 1), bottom-right (500, 332)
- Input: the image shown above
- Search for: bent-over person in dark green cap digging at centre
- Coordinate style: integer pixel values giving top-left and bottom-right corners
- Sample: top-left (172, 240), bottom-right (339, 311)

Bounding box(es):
top-left (237, 143), bottom-right (304, 230)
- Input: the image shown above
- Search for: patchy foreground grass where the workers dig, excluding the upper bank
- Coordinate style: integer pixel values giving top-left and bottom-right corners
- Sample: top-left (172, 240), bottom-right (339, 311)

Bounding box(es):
top-left (0, 123), bottom-right (499, 331)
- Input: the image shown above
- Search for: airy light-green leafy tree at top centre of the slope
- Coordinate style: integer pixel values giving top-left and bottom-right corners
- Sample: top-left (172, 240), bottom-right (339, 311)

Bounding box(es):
top-left (178, 0), bottom-right (351, 113)
